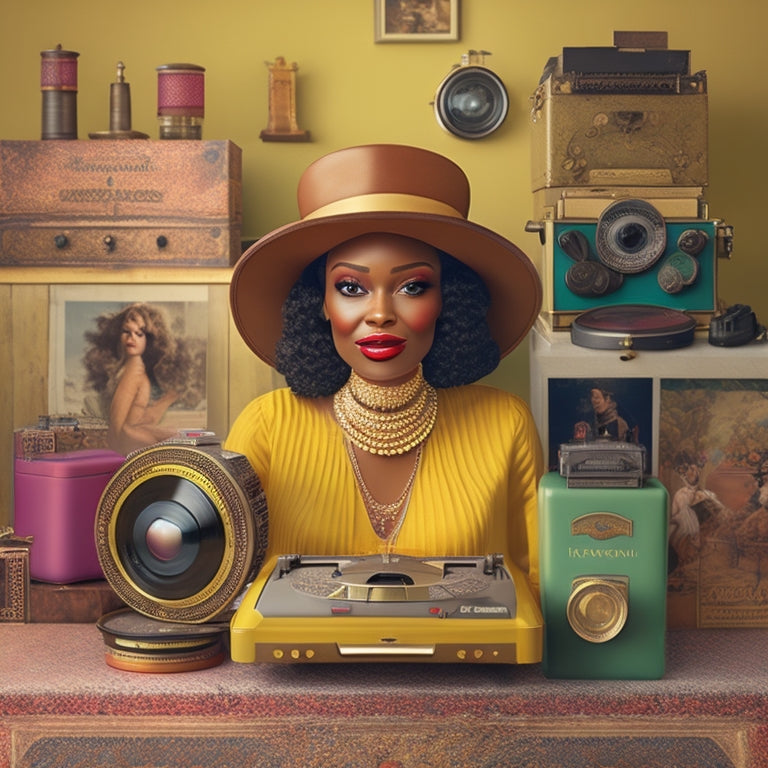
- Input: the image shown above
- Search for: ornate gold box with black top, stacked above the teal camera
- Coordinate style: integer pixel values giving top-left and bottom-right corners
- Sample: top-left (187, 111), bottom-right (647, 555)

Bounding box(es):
top-left (531, 38), bottom-right (708, 197)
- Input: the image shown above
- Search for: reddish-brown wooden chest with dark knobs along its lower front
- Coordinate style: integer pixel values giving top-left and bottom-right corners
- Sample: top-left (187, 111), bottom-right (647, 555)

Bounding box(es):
top-left (0, 140), bottom-right (242, 267)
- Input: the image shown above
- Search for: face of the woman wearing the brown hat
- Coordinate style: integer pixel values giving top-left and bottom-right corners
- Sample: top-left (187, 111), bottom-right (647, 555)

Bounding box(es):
top-left (323, 233), bottom-right (442, 385)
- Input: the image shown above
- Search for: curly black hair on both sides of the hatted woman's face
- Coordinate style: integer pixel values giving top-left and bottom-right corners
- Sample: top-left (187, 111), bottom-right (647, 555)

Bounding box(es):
top-left (275, 252), bottom-right (500, 397)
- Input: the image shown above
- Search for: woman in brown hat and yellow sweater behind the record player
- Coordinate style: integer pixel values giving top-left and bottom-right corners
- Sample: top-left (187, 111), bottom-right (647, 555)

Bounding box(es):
top-left (226, 145), bottom-right (542, 588)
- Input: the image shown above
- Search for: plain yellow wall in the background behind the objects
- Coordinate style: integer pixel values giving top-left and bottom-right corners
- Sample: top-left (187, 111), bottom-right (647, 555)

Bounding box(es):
top-left (0, 0), bottom-right (768, 402)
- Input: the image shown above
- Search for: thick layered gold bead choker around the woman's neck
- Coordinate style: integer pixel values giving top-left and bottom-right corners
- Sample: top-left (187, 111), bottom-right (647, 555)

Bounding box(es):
top-left (333, 365), bottom-right (437, 456)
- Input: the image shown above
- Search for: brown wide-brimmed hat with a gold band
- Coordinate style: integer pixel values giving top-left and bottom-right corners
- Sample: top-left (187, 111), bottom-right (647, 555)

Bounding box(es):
top-left (230, 144), bottom-right (541, 366)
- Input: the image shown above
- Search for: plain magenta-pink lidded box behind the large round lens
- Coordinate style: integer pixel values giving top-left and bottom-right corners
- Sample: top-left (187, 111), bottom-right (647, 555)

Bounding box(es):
top-left (13, 450), bottom-right (125, 584)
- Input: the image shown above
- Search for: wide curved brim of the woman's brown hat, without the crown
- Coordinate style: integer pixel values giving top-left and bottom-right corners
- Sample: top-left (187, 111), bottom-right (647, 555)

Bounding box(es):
top-left (230, 212), bottom-right (542, 366)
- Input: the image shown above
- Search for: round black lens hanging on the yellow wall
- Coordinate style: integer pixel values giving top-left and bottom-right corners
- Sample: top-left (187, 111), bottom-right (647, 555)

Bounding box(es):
top-left (435, 66), bottom-right (509, 139)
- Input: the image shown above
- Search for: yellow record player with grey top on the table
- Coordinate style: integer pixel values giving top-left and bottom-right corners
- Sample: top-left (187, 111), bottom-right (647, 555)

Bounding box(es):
top-left (230, 554), bottom-right (543, 664)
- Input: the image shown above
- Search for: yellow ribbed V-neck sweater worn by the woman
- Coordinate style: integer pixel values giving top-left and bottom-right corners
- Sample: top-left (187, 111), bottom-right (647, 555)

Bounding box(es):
top-left (225, 384), bottom-right (543, 589)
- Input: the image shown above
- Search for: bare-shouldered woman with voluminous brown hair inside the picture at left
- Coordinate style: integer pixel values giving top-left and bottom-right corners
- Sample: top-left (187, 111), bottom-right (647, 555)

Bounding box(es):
top-left (85, 304), bottom-right (189, 455)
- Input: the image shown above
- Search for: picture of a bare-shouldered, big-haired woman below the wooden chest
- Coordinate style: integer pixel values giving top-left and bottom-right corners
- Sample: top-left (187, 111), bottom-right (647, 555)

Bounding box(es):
top-left (48, 285), bottom-right (209, 453)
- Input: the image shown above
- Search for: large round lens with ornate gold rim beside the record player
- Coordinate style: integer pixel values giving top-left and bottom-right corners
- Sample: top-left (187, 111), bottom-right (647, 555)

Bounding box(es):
top-left (95, 442), bottom-right (267, 623)
